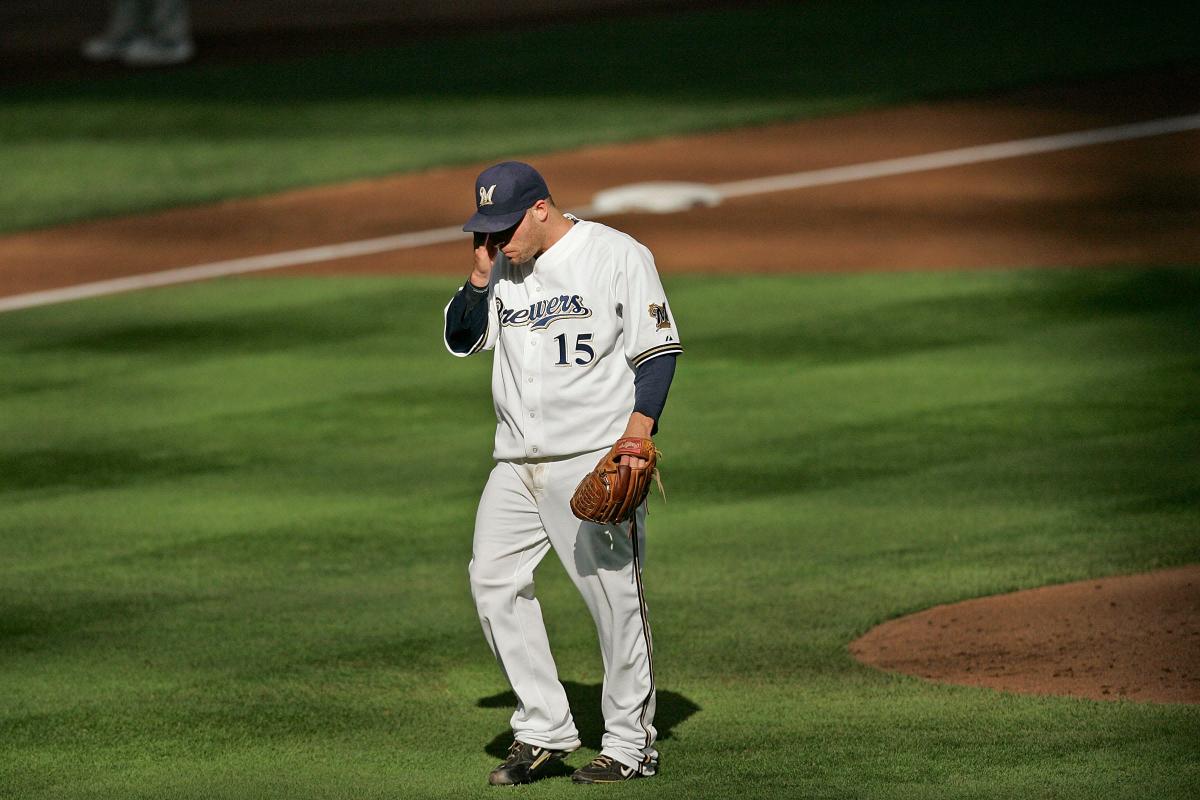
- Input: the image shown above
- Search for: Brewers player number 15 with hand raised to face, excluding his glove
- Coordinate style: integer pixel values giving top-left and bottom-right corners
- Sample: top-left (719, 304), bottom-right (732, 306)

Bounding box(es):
top-left (445, 161), bottom-right (683, 784)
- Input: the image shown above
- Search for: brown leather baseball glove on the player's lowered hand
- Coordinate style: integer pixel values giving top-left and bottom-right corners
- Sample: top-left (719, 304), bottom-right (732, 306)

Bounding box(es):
top-left (571, 437), bottom-right (661, 525)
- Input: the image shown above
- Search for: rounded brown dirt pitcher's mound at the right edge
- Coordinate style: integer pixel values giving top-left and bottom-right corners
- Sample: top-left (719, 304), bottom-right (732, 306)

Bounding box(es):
top-left (850, 565), bottom-right (1200, 703)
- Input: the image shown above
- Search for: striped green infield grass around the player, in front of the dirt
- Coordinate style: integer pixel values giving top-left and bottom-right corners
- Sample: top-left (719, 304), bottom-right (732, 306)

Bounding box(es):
top-left (0, 270), bottom-right (1200, 800)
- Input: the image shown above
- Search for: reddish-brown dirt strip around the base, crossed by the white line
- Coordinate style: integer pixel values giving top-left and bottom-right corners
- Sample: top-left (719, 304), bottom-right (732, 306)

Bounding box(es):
top-left (0, 68), bottom-right (1200, 296)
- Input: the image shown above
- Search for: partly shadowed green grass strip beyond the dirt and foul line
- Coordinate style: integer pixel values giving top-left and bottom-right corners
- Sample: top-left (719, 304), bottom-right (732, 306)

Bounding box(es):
top-left (0, 0), bottom-right (1200, 231)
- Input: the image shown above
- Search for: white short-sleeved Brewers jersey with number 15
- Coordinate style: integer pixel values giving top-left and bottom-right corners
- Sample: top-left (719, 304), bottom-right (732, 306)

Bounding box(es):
top-left (446, 221), bottom-right (683, 461)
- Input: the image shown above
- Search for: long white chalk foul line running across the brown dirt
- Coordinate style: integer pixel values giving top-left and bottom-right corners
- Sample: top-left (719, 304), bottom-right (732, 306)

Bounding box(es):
top-left (0, 114), bottom-right (1200, 312)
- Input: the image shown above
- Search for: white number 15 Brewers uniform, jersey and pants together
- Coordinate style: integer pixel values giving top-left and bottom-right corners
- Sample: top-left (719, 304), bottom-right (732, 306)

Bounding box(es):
top-left (446, 215), bottom-right (683, 775)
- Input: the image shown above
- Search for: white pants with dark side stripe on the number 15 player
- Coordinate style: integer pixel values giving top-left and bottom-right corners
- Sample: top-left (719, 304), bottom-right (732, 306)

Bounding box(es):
top-left (469, 449), bottom-right (658, 775)
